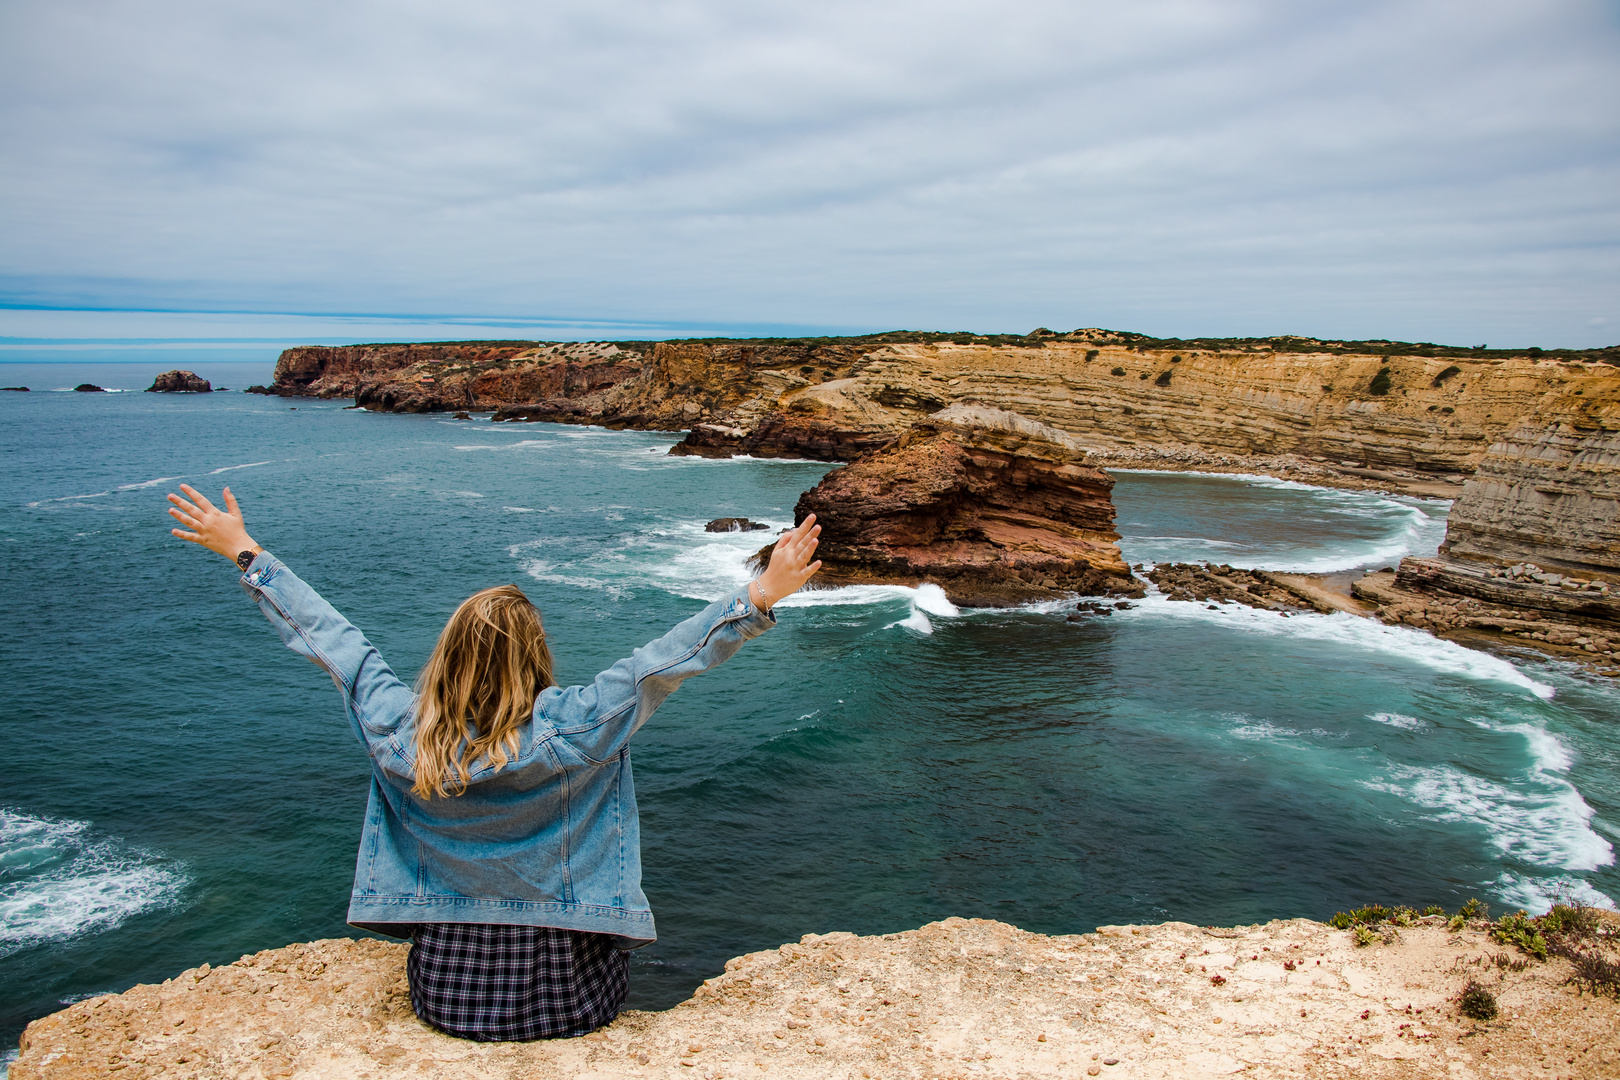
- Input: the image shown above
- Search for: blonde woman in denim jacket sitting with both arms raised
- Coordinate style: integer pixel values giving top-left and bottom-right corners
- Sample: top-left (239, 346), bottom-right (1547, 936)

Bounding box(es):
top-left (168, 484), bottom-right (821, 1041)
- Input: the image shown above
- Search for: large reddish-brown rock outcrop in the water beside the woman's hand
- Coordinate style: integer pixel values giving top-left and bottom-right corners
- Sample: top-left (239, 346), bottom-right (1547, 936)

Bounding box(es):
top-left (780, 405), bottom-right (1144, 607)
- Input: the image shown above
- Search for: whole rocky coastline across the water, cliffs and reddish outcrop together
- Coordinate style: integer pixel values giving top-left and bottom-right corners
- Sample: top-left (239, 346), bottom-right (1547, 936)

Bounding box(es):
top-left (249, 329), bottom-right (1620, 667)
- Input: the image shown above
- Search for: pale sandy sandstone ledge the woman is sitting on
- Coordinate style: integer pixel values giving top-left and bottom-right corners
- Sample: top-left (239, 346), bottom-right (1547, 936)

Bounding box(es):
top-left (11, 918), bottom-right (1620, 1080)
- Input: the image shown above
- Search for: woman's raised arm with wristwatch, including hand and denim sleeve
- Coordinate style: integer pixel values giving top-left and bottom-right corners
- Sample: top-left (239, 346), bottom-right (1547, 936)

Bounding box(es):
top-left (168, 484), bottom-right (413, 771)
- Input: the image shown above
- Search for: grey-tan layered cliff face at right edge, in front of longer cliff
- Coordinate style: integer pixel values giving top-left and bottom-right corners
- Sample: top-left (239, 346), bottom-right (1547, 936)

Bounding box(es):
top-left (1442, 377), bottom-right (1620, 581)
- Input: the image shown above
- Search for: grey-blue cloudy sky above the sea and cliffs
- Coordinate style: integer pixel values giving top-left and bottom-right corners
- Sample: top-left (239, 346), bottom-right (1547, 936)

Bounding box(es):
top-left (0, 0), bottom-right (1620, 347)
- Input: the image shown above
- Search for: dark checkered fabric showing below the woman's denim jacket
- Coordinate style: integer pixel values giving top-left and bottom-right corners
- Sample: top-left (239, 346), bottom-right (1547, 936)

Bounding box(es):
top-left (405, 923), bottom-right (630, 1043)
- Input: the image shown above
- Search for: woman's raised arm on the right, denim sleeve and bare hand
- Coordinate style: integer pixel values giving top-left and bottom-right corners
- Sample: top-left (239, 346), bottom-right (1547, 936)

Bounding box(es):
top-left (538, 515), bottom-right (821, 761)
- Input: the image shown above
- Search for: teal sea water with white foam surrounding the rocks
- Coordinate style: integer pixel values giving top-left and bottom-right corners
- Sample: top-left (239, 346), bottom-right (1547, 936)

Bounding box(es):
top-left (0, 368), bottom-right (1620, 1062)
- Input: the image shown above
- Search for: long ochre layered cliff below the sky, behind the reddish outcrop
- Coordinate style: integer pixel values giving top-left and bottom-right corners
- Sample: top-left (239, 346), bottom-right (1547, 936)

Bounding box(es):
top-left (265, 330), bottom-right (1620, 486)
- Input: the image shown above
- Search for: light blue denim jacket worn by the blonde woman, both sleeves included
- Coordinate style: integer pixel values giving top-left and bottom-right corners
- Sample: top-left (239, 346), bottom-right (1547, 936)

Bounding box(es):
top-left (241, 552), bottom-right (776, 949)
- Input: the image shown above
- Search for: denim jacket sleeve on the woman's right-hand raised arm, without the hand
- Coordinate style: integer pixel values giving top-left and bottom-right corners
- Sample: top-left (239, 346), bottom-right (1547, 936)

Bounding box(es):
top-left (536, 589), bottom-right (776, 761)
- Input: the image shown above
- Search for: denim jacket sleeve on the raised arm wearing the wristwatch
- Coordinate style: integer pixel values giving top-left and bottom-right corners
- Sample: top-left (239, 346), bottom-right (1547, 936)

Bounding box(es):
top-left (241, 552), bottom-right (415, 772)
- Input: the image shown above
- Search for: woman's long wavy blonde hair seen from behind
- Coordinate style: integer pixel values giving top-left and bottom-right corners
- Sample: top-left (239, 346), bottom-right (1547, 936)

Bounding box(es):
top-left (411, 585), bottom-right (551, 798)
